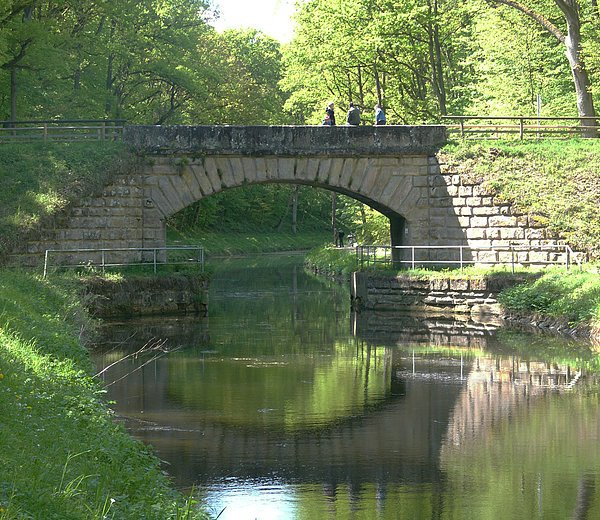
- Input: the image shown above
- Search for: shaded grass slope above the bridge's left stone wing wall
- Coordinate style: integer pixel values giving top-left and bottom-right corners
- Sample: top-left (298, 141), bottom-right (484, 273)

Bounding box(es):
top-left (0, 142), bottom-right (135, 260)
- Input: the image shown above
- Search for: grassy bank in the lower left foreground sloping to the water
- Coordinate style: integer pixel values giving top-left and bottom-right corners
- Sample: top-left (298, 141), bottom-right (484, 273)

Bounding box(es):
top-left (0, 271), bottom-right (207, 520)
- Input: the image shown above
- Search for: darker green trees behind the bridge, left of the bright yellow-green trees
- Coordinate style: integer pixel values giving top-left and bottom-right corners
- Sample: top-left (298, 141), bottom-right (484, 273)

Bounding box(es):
top-left (0, 0), bottom-right (284, 124)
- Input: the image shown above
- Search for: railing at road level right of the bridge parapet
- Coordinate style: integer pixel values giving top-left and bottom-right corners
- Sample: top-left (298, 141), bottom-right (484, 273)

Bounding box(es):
top-left (442, 116), bottom-right (600, 139)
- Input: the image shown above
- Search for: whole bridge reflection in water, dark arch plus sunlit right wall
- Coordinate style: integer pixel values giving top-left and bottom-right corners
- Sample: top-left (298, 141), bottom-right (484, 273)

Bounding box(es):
top-left (96, 313), bottom-right (592, 498)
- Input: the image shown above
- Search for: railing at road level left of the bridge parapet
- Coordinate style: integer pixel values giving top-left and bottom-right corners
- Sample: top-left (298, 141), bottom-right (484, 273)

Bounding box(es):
top-left (0, 119), bottom-right (125, 143)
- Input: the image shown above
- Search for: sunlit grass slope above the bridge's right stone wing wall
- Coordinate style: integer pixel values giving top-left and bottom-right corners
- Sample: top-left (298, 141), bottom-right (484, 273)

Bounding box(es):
top-left (440, 139), bottom-right (600, 259)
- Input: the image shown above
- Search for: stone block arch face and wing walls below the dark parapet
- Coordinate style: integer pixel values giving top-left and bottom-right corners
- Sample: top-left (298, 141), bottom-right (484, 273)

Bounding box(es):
top-left (9, 140), bottom-right (565, 265)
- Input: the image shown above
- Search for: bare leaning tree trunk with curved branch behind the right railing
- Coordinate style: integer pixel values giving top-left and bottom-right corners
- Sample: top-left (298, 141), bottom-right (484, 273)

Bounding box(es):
top-left (487, 0), bottom-right (597, 137)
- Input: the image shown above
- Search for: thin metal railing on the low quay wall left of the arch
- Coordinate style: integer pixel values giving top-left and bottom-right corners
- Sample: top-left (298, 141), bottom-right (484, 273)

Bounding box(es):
top-left (44, 246), bottom-right (205, 278)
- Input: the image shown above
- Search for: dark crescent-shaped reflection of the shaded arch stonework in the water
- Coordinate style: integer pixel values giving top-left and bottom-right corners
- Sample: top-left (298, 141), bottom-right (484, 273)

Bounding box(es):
top-left (130, 366), bottom-right (460, 489)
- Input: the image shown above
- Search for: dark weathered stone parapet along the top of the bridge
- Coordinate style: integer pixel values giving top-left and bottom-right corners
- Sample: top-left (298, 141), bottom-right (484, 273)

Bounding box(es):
top-left (123, 125), bottom-right (446, 157)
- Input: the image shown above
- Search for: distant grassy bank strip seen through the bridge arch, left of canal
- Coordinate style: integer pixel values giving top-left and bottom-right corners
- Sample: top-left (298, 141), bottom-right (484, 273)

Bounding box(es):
top-left (167, 229), bottom-right (331, 261)
